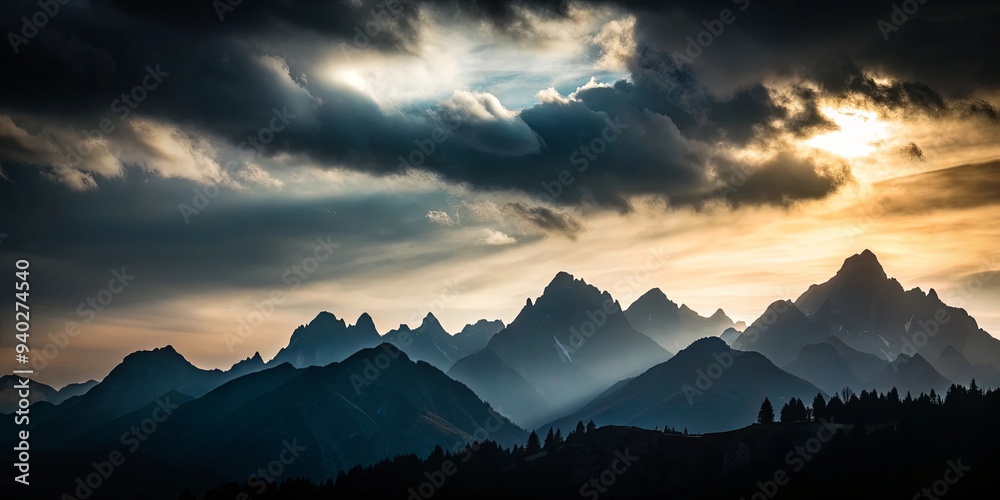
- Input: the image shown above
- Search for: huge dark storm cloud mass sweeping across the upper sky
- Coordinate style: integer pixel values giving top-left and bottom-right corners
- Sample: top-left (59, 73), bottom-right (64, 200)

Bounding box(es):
top-left (0, 0), bottom-right (998, 211)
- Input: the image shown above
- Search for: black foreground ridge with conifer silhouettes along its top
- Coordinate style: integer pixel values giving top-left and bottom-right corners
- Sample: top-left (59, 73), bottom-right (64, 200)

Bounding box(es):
top-left (189, 383), bottom-right (1000, 500)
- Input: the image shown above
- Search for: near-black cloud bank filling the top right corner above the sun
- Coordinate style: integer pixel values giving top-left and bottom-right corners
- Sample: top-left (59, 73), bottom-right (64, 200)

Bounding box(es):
top-left (621, 0), bottom-right (1000, 97)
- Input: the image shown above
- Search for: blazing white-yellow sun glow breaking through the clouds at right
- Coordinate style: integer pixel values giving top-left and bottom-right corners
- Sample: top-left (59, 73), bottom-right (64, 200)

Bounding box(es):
top-left (805, 107), bottom-right (889, 158)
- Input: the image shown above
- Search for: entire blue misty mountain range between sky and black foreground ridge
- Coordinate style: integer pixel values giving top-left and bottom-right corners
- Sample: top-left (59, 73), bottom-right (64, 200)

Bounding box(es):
top-left (0, 250), bottom-right (1000, 496)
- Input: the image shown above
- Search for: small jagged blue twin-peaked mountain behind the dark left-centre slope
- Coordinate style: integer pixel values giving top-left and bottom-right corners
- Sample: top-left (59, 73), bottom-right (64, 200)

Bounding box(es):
top-left (267, 311), bottom-right (382, 368)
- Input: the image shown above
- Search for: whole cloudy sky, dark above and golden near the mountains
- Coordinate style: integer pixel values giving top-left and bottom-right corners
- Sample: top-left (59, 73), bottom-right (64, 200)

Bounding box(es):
top-left (0, 0), bottom-right (1000, 387)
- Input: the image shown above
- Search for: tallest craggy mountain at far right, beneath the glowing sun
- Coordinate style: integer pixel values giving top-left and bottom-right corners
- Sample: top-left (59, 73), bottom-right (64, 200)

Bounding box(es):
top-left (734, 250), bottom-right (1000, 390)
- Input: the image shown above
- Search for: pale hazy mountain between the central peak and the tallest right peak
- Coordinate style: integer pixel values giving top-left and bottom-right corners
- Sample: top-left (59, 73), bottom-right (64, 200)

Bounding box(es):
top-left (625, 288), bottom-right (735, 352)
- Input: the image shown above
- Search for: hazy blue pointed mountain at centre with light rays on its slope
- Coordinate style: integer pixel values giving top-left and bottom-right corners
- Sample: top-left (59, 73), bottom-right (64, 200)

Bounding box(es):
top-left (448, 273), bottom-right (670, 426)
